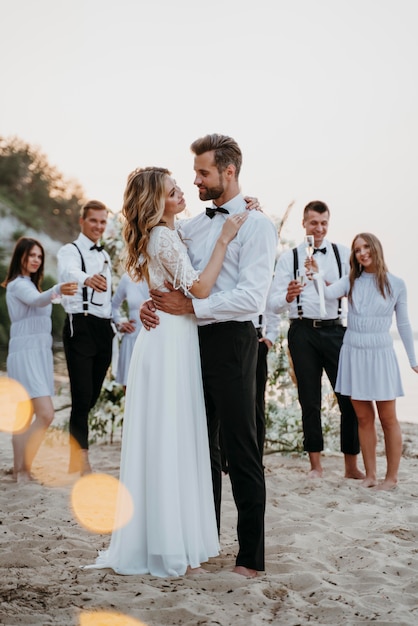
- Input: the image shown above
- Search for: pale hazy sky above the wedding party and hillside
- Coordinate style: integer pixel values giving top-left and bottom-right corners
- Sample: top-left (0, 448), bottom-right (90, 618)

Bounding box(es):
top-left (0, 0), bottom-right (418, 330)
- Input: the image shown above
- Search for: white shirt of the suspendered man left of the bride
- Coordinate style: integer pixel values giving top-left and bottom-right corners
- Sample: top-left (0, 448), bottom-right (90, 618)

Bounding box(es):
top-left (57, 233), bottom-right (112, 319)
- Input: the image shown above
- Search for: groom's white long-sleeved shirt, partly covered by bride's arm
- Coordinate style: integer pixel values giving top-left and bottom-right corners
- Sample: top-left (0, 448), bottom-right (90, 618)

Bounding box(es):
top-left (178, 194), bottom-right (277, 326)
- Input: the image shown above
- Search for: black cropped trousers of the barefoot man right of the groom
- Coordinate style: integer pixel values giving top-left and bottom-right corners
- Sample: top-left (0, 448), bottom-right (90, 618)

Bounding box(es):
top-left (288, 321), bottom-right (360, 454)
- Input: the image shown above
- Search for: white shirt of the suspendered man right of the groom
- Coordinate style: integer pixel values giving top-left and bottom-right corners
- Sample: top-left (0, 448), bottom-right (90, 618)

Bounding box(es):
top-left (269, 239), bottom-right (350, 319)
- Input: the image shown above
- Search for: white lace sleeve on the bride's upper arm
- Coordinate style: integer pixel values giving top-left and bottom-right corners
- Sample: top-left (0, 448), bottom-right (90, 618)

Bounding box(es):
top-left (158, 227), bottom-right (199, 294)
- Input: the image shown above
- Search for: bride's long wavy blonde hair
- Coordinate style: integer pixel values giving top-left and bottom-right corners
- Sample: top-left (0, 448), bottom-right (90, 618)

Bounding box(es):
top-left (122, 167), bottom-right (171, 282)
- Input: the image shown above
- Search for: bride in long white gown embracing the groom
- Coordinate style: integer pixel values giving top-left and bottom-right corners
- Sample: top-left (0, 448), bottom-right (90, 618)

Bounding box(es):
top-left (87, 167), bottom-right (248, 577)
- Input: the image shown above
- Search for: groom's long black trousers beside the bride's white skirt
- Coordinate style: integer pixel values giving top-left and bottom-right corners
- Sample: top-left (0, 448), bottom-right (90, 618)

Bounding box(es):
top-left (199, 322), bottom-right (266, 571)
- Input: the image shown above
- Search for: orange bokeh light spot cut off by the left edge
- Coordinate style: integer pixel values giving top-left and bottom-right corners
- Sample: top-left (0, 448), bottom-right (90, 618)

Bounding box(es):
top-left (0, 376), bottom-right (33, 433)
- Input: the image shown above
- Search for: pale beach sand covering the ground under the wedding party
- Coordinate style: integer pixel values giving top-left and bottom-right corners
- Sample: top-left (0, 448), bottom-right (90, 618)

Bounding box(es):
top-left (0, 372), bottom-right (418, 626)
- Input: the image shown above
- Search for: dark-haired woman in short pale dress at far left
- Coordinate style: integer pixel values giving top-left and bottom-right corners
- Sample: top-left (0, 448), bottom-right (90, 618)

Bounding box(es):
top-left (2, 237), bottom-right (77, 482)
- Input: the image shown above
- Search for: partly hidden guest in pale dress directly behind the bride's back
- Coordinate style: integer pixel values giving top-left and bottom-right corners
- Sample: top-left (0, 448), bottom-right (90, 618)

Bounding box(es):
top-left (112, 272), bottom-right (149, 387)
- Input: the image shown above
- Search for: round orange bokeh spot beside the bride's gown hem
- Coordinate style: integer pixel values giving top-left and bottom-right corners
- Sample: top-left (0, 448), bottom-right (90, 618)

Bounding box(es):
top-left (71, 474), bottom-right (134, 534)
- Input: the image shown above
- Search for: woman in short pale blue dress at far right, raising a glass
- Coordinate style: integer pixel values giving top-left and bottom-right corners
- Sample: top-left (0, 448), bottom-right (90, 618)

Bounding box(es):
top-left (307, 233), bottom-right (418, 490)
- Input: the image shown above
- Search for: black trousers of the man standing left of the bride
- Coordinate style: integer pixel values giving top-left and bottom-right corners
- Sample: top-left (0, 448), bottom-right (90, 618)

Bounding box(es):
top-left (63, 313), bottom-right (114, 470)
